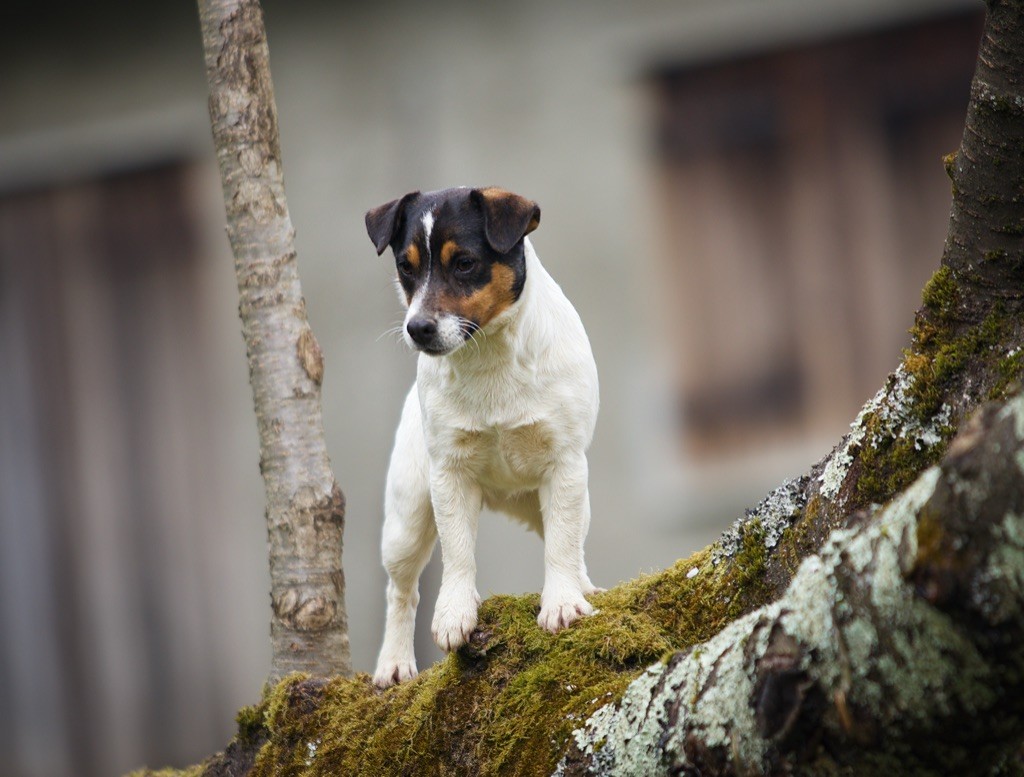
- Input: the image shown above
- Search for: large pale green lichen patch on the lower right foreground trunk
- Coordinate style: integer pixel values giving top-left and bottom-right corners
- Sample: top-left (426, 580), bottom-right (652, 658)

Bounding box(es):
top-left (561, 468), bottom-right (950, 774)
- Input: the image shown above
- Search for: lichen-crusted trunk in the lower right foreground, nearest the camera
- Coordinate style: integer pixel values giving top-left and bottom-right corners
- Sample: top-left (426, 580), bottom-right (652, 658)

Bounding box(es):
top-left (559, 396), bottom-right (1024, 775)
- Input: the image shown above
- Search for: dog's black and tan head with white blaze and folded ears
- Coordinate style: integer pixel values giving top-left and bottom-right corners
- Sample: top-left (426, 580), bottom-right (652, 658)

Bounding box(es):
top-left (367, 188), bottom-right (541, 356)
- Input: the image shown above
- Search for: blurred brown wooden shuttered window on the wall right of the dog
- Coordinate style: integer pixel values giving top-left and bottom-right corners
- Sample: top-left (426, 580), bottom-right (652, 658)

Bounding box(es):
top-left (652, 7), bottom-right (981, 452)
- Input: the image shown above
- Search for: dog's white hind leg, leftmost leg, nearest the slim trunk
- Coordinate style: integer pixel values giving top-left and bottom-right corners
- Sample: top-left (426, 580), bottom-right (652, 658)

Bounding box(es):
top-left (374, 387), bottom-right (437, 688)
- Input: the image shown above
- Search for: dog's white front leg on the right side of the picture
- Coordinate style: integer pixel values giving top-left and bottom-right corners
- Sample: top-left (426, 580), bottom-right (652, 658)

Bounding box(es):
top-left (537, 454), bottom-right (594, 634)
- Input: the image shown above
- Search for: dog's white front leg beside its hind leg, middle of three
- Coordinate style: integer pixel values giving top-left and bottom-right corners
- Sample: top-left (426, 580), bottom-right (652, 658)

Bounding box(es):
top-left (430, 469), bottom-right (483, 652)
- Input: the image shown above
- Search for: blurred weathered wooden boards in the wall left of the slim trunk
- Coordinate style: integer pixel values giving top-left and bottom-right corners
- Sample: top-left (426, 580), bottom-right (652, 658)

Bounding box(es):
top-left (0, 163), bottom-right (243, 776)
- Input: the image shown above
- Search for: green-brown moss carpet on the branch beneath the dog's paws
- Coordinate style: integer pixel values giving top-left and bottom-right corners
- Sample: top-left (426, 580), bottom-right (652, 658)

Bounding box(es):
top-left (161, 520), bottom-right (770, 777)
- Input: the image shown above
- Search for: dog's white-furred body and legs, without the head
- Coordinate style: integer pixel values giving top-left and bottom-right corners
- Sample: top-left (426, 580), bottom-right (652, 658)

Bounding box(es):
top-left (374, 237), bottom-right (599, 687)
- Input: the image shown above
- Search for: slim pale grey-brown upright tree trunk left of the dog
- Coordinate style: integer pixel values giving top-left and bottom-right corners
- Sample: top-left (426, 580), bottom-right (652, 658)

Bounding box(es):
top-left (199, 0), bottom-right (351, 680)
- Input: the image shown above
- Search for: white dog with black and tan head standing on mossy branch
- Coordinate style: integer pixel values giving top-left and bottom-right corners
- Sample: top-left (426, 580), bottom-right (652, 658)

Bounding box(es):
top-left (366, 188), bottom-right (602, 688)
